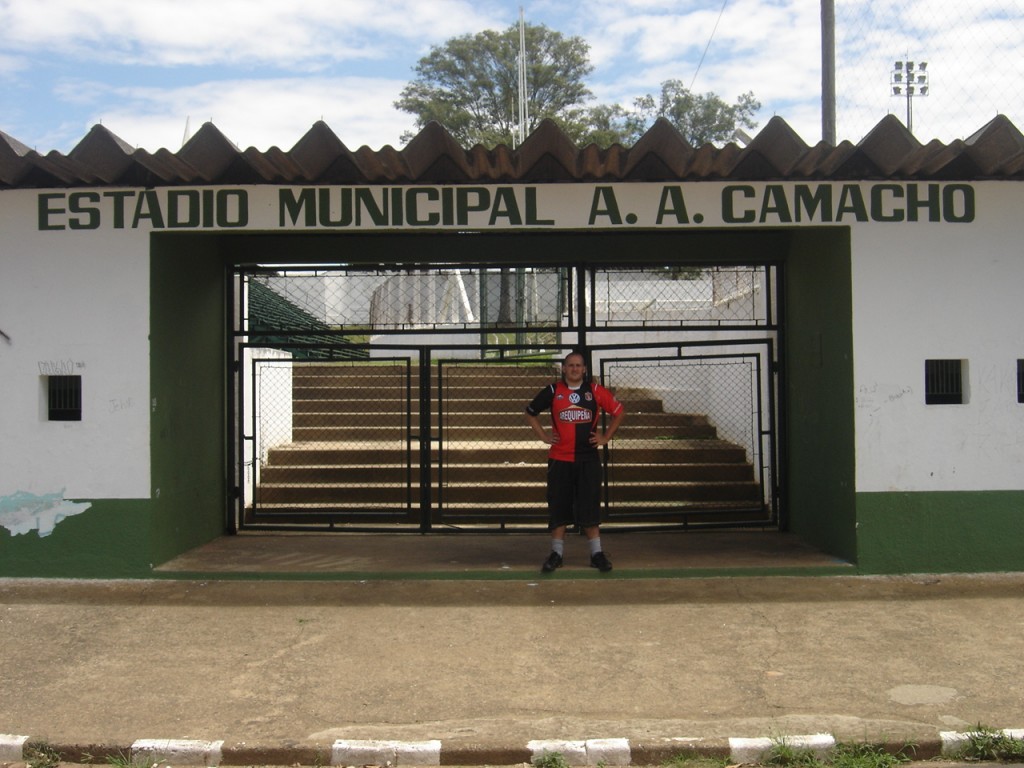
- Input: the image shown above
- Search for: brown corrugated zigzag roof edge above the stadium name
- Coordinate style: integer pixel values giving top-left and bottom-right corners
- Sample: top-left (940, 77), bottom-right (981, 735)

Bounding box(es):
top-left (0, 115), bottom-right (1024, 188)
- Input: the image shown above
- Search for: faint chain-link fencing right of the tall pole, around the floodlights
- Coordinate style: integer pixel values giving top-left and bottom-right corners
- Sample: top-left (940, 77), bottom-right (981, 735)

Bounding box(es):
top-left (836, 0), bottom-right (1024, 143)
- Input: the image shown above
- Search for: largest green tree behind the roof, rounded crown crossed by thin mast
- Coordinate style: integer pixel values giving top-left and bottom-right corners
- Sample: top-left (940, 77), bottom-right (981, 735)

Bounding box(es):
top-left (394, 24), bottom-right (593, 147)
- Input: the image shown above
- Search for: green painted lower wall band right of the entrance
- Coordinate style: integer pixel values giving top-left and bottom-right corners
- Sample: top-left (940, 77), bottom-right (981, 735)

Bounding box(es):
top-left (857, 490), bottom-right (1024, 573)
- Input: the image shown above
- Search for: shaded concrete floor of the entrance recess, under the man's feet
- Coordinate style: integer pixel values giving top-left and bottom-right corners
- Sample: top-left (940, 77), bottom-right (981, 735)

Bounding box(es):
top-left (151, 528), bottom-right (852, 579)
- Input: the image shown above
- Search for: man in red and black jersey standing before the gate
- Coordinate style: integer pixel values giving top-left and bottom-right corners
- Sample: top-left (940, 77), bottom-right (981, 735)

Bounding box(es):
top-left (526, 352), bottom-right (626, 573)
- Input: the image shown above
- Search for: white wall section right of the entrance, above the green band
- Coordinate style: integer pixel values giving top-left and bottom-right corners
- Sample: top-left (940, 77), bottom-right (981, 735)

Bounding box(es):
top-left (852, 181), bottom-right (1024, 492)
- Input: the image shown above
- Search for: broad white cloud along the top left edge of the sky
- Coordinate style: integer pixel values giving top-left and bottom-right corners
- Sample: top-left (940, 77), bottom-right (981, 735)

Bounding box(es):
top-left (0, 0), bottom-right (503, 70)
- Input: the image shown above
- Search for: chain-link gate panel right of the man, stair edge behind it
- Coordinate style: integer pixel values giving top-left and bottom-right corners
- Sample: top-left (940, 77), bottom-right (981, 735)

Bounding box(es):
top-left (602, 354), bottom-right (771, 523)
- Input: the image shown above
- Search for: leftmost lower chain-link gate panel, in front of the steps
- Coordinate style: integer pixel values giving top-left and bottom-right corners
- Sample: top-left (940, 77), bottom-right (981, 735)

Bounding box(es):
top-left (252, 358), bottom-right (419, 521)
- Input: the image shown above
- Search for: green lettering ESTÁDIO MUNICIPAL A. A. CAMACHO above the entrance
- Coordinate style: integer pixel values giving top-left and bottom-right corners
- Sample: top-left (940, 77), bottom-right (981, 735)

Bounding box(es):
top-left (37, 182), bottom-right (976, 231)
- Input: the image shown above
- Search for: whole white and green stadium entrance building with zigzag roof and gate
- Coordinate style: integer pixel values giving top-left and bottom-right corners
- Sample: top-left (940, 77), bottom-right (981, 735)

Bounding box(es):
top-left (0, 118), bottom-right (1024, 578)
